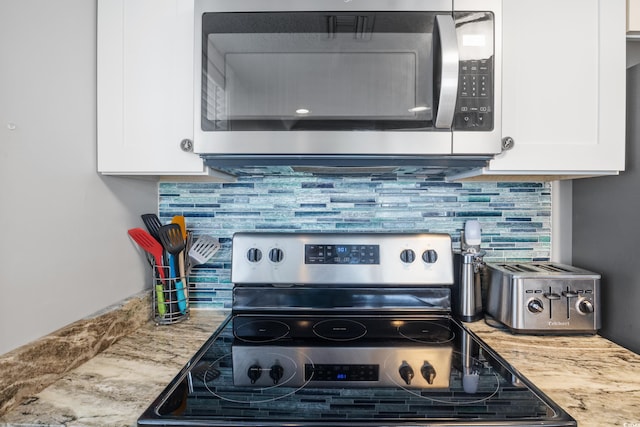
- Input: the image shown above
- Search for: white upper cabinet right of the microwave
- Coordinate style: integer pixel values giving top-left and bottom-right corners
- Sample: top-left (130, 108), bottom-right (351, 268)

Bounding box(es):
top-left (484, 0), bottom-right (625, 175)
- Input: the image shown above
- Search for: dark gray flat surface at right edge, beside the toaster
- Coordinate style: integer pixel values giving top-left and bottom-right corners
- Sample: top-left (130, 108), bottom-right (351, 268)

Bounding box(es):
top-left (573, 65), bottom-right (640, 353)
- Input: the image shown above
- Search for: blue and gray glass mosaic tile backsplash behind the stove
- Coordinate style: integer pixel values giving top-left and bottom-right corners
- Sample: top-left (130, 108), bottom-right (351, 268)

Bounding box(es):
top-left (159, 176), bottom-right (551, 308)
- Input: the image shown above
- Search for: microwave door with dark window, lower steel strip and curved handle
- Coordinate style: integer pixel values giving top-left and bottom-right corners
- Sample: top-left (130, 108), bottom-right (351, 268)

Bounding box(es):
top-left (194, 9), bottom-right (459, 157)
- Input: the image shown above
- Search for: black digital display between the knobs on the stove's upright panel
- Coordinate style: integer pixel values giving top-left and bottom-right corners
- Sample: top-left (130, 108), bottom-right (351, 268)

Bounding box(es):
top-left (304, 245), bottom-right (380, 265)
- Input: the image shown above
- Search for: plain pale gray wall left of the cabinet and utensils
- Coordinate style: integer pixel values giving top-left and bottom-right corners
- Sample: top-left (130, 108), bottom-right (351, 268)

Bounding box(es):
top-left (0, 0), bottom-right (157, 354)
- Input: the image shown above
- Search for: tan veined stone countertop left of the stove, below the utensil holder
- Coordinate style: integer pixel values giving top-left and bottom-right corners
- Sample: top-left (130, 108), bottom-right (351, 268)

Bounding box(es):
top-left (0, 310), bottom-right (226, 426)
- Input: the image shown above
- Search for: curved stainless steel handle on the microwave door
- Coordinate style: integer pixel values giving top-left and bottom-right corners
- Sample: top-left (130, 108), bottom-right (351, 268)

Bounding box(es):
top-left (435, 15), bottom-right (460, 129)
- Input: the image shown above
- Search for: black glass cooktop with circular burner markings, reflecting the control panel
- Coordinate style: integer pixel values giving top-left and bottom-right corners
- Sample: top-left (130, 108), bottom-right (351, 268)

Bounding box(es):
top-left (138, 315), bottom-right (577, 426)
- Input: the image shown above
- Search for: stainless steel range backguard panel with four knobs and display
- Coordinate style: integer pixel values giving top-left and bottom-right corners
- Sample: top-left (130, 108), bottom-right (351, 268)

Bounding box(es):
top-left (231, 232), bottom-right (453, 286)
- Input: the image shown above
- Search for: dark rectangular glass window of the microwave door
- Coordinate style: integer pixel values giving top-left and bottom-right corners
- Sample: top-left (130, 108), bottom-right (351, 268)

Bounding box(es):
top-left (201, 12), bottom-right (440, 131)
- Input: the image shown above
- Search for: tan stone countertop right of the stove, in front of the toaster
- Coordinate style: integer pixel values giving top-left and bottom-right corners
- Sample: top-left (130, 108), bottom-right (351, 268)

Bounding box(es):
top-left (467, 321), bottom-right (640, 427)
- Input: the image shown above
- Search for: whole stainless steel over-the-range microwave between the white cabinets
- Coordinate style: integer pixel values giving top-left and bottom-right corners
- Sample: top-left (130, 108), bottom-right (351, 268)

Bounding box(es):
top-left (194, 0), bottom-right (501, 171)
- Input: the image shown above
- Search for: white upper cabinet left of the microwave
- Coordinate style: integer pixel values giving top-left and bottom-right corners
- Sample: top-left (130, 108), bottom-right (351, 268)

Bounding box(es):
top-left (98, 0), bottom-right (206, 175)
